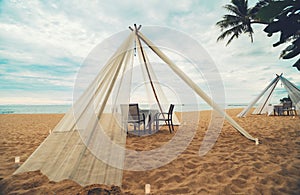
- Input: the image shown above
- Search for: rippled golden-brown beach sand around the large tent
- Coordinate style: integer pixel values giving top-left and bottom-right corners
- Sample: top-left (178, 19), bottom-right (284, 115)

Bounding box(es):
top-left (0, 109), bottom-right (300, 194)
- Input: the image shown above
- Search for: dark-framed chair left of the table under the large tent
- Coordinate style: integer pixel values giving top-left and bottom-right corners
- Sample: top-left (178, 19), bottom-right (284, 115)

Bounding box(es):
top-left (121, 104), bottom-right (145, 133)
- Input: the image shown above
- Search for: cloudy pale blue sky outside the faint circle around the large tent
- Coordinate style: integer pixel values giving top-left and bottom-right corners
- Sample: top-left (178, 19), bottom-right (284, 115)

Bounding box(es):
top-left (0, 0), bottom-right (300, 105)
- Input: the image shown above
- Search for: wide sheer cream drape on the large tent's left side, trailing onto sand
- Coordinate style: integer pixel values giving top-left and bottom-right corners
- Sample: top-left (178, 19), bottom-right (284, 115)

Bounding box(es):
top-left (15, 33), bottom-right (134, 186)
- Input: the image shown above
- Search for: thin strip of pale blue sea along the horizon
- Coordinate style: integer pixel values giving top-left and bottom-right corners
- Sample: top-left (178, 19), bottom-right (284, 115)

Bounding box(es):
top-left (0, 103), bottom-right (247, 114)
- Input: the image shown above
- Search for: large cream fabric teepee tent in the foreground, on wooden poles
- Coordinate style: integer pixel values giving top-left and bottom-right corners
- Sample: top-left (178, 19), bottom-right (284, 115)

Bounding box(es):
top-left (14, 26), bottom-right (258, 186)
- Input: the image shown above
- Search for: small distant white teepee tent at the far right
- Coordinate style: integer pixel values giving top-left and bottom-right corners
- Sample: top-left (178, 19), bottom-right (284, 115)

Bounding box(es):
top-left (237, 74), bottom-right (300, 117)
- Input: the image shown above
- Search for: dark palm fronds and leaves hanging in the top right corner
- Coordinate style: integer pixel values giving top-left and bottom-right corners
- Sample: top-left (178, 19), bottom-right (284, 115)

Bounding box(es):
top-left (216, 0), bottom-right (300, 71)
